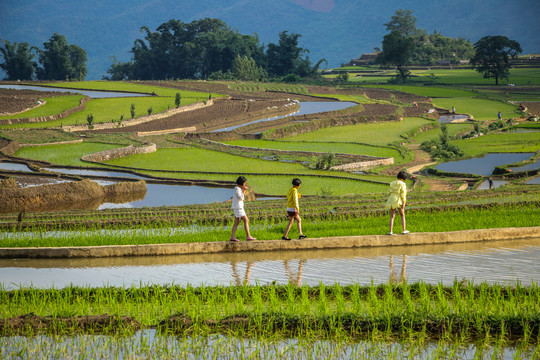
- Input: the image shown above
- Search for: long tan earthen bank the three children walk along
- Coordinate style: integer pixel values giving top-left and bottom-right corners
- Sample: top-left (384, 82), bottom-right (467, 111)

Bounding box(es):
top-left (0, 226), bottom-right (540, 259)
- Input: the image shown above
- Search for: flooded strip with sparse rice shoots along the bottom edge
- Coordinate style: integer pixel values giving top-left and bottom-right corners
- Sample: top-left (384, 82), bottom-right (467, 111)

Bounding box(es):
top-left (0, 329), bottom-right (535, 360)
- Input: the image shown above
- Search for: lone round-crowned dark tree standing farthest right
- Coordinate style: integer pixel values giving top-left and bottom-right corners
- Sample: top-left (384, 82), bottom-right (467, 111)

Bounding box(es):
top-left (471, 35), bottom-right (523, 85)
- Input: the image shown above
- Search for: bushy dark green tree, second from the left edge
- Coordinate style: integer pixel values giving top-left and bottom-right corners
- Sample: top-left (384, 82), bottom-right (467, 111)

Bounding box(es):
top-left (37, 33), bottom-right (87, 81)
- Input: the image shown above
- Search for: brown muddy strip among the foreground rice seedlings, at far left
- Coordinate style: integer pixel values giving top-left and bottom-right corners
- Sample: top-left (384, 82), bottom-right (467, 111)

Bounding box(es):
top-left (0, 314), bottom-right (141, 334)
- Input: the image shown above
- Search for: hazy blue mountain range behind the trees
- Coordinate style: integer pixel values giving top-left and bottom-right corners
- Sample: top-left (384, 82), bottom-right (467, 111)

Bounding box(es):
top-left (0, 0), bottom-right (540, 80)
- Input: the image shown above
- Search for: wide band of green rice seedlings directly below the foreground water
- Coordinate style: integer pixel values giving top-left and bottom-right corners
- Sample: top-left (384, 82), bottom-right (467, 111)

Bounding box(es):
top-left (0, 282), bottom-right (540, 351)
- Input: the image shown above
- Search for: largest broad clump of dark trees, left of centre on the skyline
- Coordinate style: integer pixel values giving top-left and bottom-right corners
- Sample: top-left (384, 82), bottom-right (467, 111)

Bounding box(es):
top-left (124, 18), bottom-right (264, 79)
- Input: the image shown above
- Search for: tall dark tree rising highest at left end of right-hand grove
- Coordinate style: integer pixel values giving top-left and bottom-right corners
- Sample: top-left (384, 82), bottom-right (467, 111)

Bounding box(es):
top-left (377, 30), bottom-right (414, 82)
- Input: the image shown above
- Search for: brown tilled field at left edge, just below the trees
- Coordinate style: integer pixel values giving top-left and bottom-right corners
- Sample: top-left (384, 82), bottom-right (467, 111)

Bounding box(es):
top-left (0, 89), bottom-right (69, 115)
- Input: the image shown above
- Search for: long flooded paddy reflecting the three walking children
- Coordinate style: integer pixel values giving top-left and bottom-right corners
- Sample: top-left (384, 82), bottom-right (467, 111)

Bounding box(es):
top-left (0, 239), bottom-right (540, 289)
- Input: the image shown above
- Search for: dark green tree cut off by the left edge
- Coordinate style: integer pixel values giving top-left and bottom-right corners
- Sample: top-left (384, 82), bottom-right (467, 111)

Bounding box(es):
top-left (0, 40), bottom-right (37, 80)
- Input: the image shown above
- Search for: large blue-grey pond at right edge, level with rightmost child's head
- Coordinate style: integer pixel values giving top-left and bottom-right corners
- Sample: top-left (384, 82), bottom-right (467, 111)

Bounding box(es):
top-left (435, 153), bottom-right (534, 175)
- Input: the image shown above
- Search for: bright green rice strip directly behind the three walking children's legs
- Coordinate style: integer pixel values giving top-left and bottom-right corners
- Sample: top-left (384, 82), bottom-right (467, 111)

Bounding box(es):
top-left (2, 202), bottom-right (540, 247)
